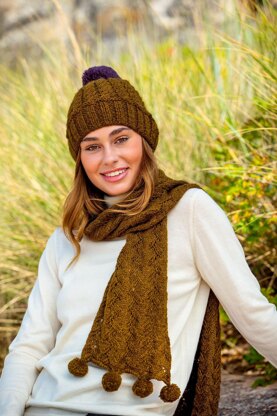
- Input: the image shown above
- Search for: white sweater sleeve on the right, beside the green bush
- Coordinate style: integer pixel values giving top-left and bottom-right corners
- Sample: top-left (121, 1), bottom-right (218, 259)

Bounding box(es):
top-left (191, 190), bottom-right (277, 367)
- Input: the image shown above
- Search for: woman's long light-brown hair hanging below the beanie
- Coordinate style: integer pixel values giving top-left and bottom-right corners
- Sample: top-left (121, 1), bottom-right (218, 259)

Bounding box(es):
top-left (62, 138), bottom-right (158, 267)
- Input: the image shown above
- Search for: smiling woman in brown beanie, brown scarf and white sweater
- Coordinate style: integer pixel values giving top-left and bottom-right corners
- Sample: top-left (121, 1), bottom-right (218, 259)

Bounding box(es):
top-left (0, 67), bottom-right (277, 416)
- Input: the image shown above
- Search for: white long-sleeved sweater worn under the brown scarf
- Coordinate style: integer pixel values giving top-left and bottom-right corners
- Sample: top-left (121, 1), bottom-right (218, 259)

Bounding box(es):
top-left (0, 189), bottom-right (277, 416)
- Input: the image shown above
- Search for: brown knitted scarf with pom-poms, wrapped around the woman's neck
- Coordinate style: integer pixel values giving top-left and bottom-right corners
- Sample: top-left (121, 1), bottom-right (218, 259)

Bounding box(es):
top-left (68, 170), bottom-right (219, 416)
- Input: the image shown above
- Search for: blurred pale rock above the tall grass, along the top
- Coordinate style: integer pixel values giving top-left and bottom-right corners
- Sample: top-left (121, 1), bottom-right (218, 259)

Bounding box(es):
top-left (0, 0), bottom-right (277, 62)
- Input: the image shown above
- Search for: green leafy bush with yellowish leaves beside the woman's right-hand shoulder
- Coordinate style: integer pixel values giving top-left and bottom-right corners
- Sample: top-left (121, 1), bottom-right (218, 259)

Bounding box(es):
top-left (205, 149), bottom-right (277, 289)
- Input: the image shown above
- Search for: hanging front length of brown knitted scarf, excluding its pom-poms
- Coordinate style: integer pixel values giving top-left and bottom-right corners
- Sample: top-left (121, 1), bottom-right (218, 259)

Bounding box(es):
top-left (81, 221), bottom-right (171, 383)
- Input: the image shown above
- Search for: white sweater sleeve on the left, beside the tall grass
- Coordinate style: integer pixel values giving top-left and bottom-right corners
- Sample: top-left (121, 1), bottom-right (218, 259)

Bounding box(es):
top-left (0, 230), bottom-right (60, 416)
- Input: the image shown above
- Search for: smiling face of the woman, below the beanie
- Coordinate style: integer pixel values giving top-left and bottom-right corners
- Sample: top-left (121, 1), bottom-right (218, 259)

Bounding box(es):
top-left (80, 126), bottom-right (143, 196)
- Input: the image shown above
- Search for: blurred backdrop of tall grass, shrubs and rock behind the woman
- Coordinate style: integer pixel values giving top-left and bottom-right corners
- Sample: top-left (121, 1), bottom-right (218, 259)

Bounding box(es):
top-left (0, 0), bottom-right (277, 385)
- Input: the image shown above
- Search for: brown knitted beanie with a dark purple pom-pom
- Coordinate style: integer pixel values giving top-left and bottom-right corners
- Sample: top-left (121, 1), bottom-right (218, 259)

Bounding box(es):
top-left (66, 66), bottom-right (159, 160)
